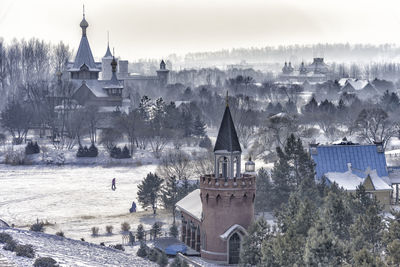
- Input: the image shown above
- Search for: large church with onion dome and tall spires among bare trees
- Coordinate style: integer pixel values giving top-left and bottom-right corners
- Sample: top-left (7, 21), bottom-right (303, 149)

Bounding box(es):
top-left (61, 7), bottom-right (169, 112)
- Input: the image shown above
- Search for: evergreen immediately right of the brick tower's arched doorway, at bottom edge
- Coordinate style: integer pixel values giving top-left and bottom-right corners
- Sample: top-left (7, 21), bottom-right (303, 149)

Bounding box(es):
top-left (240, 219), bottom-right (271, 266)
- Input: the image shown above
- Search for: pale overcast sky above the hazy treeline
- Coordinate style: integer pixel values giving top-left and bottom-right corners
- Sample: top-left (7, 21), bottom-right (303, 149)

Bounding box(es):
top-left (0, 0), bottom-right (400, 60)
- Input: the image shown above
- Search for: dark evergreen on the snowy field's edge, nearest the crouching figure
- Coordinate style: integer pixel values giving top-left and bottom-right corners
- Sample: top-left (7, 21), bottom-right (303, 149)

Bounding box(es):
top-left (137, 172), bottom-right (163, 214)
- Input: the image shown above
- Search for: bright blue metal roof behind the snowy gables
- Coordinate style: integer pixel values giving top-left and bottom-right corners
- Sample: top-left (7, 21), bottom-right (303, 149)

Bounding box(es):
top-left (310, 145), bottom-right (388, 179)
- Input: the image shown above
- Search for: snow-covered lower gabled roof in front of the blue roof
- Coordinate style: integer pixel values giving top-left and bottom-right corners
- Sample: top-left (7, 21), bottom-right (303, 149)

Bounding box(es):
top-left (325, 170), bottom-right (392, 191)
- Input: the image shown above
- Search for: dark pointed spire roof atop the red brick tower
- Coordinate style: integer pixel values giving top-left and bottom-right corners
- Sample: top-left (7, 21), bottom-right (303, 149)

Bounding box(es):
top-left (214, 105), bottom-right (242, 152)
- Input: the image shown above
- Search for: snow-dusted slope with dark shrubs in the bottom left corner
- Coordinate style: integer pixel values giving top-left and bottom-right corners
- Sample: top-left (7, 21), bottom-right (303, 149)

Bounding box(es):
top-left (0, 228), bottom-right (158, 267)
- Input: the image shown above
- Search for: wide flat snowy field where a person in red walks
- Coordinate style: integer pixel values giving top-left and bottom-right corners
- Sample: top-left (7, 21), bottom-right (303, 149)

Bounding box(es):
top-left (0, 164), bottom-right (175, 244)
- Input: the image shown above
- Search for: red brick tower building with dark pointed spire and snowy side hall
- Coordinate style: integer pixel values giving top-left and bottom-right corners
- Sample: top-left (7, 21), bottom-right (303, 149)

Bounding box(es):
top-left (177, 101), bottom-right (256, 264)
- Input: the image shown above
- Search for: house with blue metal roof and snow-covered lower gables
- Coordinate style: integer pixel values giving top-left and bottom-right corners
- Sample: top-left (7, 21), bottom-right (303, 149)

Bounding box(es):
top-left (310, 139), bottom-right (392, 211)
